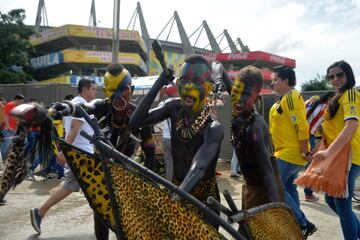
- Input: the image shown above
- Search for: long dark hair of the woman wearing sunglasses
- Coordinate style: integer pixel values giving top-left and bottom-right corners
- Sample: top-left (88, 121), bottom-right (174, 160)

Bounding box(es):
top-left (326, 60), bottom-right (355, 119)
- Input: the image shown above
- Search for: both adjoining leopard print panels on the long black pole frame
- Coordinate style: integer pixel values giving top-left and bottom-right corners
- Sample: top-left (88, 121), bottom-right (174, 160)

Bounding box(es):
top-left (59, 141), bottom-right (224, 240)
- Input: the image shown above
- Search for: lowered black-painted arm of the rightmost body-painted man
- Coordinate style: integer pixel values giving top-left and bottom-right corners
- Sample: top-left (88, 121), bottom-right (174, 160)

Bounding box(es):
top-left (247, 122), bottom-right (281, 202)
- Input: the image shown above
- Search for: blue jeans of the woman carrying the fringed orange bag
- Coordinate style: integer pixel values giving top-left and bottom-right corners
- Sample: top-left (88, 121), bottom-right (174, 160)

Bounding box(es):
top-left (325, 164), bottom-right (360, 240)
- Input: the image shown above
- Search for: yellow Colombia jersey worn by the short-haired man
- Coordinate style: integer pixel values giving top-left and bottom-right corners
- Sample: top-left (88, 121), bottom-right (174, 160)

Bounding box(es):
top-left (269, 90), bottom-right (309, 166)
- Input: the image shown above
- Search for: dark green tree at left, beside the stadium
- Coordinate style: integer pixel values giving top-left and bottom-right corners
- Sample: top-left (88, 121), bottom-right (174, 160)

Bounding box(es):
top-left (0, 9), bottom-right (35, 84)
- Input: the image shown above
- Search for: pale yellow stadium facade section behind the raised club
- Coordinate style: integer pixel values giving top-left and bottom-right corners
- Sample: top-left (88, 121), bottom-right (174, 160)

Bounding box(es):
top-left (149, 51), bottom-right (185, 76)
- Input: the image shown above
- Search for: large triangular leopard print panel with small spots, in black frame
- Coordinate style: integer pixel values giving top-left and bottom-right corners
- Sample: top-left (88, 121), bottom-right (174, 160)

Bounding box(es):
top-left (111, 164), bottom-right (223, 240)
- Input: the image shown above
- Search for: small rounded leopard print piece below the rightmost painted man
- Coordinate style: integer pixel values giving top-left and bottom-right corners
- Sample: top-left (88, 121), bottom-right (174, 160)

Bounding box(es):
top-left (245, 207), bottom-right (303, 240)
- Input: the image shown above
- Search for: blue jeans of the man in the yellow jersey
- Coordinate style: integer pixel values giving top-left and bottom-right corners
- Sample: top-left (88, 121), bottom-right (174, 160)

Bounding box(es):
top-left (277, 158), bottom-right (308, 227)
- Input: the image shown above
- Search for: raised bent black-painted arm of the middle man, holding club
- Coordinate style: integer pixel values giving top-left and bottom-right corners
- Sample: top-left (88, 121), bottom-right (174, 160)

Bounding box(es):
top-left (129, 69), bottom-right (173, 128)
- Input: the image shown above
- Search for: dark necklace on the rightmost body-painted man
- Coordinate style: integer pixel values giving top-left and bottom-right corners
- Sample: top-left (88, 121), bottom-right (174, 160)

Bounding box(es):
top-left (230, 112), bottom-right (255, 150)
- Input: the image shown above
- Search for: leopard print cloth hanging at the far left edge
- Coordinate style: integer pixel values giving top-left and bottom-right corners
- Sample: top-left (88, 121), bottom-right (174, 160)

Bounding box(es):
top-left (0, 125), bottom-right (27, 199)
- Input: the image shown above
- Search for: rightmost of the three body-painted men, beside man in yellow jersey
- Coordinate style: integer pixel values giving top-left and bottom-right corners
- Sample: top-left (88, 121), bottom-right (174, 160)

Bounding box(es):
top-left (213, 63), bottom-right (282, 210)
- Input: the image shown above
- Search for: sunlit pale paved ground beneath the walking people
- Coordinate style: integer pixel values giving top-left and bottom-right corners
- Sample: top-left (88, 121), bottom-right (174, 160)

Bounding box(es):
top-left (0, 162), bottom-right (360, 240)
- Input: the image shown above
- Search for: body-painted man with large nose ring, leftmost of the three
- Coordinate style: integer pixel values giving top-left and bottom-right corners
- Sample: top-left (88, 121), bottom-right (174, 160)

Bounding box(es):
top-left (90, 64), bottom-right (155, 239)
